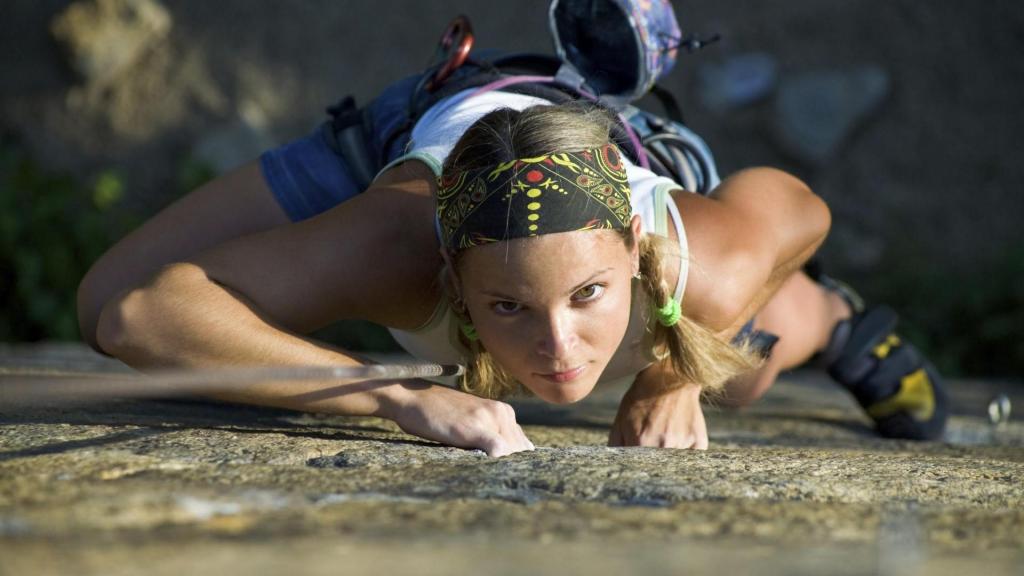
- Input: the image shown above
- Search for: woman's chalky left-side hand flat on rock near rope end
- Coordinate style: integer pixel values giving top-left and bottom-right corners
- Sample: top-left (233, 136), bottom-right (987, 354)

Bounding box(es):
top-left (392, 384), bottom-right (534, 457)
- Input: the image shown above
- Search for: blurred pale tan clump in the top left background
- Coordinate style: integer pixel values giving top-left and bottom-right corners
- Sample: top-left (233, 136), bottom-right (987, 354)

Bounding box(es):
top-left (50, 0), bottom-right (171, 86)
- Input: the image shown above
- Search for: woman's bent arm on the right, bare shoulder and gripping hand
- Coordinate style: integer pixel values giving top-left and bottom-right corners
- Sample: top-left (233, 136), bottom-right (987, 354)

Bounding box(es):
top-left (608, 168), bottom-right (831, 449)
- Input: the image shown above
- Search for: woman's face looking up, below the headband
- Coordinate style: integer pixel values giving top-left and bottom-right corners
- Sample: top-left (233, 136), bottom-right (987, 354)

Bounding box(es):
top-left (459, 218), bottom-right (639, 404)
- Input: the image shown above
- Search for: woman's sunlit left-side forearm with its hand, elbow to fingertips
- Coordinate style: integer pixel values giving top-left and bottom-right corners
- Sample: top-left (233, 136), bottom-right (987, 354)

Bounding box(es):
top-left (100, 259), bottom-right (534, 456)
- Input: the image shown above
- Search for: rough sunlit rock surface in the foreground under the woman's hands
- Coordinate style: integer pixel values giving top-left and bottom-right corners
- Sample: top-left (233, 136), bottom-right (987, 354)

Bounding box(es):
top-left (0, 342), bottom-right (1024, 574)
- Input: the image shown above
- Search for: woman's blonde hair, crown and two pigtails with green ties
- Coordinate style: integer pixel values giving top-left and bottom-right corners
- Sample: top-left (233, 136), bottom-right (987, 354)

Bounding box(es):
top-left (442, 102), bottom-right (759, 399)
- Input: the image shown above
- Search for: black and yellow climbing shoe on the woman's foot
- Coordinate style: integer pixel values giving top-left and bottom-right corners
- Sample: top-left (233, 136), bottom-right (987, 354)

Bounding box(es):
top-left (814, 277), bottom-right (949, 440)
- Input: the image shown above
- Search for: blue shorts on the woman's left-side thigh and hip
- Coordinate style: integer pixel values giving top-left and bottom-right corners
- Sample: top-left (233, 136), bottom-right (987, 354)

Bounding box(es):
top-left (259, 75), bottom-right (428, 221)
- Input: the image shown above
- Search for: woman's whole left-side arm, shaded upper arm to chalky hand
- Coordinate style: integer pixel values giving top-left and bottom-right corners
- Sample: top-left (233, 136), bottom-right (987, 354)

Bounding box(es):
top-left (97, 162), bottom-right (531, 455)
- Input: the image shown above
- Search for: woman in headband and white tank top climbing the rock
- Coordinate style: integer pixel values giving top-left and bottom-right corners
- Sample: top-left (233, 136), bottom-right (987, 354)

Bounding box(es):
top-left (79, 2), bottom-right (945, 456)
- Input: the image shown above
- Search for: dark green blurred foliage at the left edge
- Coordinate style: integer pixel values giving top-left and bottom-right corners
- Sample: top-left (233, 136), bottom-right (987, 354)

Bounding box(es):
top-left (0, 142), bottom-right (132, 341)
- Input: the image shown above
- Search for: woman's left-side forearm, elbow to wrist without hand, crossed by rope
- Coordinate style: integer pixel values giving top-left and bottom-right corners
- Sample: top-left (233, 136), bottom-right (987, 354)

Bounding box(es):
top-left (98, 260), bottom-right (429, 419)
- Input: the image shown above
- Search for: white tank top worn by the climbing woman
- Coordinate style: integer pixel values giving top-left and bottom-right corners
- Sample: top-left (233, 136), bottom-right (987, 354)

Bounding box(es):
top-left (381, 89), bottom-right (689, 384)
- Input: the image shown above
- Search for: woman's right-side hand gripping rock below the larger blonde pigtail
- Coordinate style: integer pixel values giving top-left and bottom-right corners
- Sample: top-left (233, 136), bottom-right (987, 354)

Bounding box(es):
top-left (608, 368), bottom-right (708, 450)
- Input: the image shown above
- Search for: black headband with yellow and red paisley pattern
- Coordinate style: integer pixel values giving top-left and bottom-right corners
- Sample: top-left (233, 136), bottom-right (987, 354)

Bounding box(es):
top-left (437, 143), bottom-right (633, 252)
